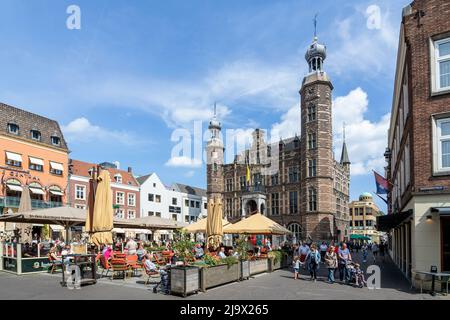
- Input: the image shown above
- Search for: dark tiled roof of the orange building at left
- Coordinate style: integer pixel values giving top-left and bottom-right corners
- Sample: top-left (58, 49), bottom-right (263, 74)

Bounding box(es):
top-left (0, 103), bottom-right (68, 151)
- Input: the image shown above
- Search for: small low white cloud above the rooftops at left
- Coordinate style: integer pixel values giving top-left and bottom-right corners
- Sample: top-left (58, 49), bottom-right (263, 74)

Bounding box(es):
top-left (61, 117), bottom-right (141, 144)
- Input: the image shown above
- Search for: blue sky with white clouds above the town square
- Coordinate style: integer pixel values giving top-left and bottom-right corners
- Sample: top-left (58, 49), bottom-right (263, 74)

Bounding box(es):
top-left (0, 0), bottom-right (409, 209)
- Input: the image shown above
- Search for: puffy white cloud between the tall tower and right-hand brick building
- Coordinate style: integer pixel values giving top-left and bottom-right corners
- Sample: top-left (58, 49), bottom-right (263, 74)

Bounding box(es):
top-left (333, 87), bottom-right (390, 175)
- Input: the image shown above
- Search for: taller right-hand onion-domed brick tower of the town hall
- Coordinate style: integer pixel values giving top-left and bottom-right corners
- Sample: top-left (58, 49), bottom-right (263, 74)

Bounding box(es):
top-left (300, 31), bottom-right (335, 240)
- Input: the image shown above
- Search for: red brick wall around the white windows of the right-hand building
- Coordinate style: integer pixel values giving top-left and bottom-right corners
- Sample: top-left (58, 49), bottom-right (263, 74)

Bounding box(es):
top-left (404, 0), bottom-right (450, 191)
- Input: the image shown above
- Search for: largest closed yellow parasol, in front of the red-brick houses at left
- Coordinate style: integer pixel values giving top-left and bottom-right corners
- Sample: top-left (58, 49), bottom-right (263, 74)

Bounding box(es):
top-left (86, 170), bottom-right (114, 246)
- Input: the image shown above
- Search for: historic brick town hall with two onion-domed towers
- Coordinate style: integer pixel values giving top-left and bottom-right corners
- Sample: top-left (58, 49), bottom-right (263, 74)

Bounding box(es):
top-left (207, 38), bottom-right (350, 240)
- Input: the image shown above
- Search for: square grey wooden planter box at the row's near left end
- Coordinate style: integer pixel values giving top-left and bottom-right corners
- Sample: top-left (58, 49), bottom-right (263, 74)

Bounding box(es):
top-left (170, 266), bottom-right (200, 297)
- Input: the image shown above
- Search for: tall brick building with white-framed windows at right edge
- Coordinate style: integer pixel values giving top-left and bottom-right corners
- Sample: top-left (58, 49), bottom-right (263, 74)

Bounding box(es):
top-left (379, 0), bottom-right (450, 279)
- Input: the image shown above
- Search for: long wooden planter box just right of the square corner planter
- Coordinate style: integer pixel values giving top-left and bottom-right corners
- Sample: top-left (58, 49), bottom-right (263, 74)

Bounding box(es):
top-left (200, 263), bottom-right (240, 291)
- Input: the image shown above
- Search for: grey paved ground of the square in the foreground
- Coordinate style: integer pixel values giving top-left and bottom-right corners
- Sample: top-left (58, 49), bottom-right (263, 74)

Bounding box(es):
top-left (0, 254), bottom-right (449, 300)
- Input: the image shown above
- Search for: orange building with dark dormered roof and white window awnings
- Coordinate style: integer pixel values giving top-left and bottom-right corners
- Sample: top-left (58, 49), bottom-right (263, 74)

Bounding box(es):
top-left (0, 103), bottom-right (69, 242)
